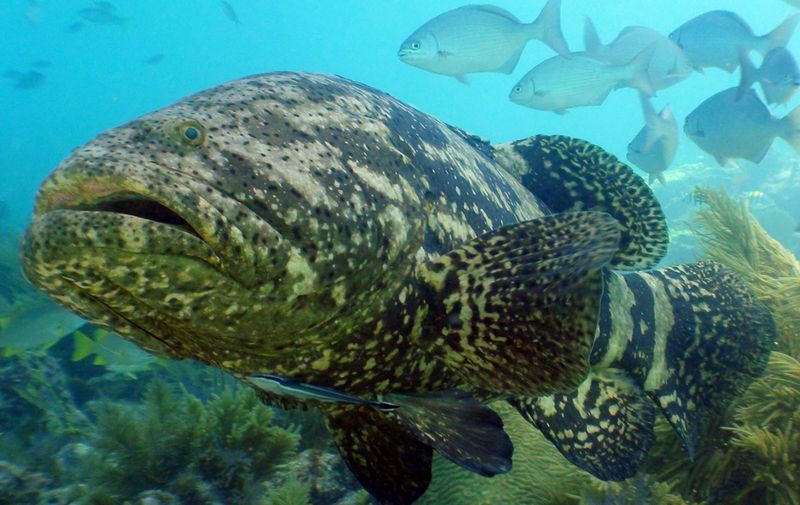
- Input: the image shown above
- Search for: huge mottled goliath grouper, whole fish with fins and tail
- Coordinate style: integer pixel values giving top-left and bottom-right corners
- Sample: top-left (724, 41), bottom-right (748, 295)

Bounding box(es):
top-left (22, 73), bottom-right (775, 504)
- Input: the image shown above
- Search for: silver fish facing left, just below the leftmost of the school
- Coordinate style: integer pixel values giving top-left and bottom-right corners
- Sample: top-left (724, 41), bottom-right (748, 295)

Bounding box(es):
top-left (508, 48), bottom-right (653, 114)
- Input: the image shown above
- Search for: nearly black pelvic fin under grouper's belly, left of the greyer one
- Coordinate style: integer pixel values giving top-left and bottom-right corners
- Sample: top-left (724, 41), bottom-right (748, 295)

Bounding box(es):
top-left (323, 406), bottom-right (433, 505)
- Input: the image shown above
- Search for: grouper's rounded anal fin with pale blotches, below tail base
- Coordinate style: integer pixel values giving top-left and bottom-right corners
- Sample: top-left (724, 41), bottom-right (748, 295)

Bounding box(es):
top-left (509, 369), bottom-right (656, 480)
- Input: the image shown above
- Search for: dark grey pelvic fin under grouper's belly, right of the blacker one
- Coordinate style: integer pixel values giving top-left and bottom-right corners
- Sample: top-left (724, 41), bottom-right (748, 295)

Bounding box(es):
top-left (386, 391), bottom-right (514, 477)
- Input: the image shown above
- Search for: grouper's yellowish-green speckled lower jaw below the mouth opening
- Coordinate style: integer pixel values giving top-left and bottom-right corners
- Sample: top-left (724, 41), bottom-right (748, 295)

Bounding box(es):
top-left (22, 210), bottom-right (241, 360)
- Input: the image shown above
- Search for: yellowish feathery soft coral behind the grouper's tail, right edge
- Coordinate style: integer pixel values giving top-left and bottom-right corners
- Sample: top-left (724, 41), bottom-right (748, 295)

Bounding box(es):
top-left (648, 189), bottom-right (800, 505)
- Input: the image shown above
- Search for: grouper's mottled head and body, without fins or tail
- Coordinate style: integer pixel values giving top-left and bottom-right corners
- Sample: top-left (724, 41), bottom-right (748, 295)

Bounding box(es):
top-left (24, 73), bottom-right (544, 395)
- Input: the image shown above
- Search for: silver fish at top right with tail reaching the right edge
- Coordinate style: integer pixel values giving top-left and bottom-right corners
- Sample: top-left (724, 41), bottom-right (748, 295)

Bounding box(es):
top-left (669, 11), bottom-right (800, 72)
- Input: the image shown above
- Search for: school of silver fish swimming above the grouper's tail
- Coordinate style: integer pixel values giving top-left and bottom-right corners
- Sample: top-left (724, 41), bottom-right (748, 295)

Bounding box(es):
top-left (399, 0), bottom-right (800, 179)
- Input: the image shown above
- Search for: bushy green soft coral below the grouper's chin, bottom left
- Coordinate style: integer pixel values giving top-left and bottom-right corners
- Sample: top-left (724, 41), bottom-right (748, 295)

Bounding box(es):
top-left (68, 381), bottom-right (299, 504)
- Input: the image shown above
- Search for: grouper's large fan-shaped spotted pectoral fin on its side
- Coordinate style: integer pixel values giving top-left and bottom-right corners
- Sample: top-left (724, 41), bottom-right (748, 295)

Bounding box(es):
top-left (419, 212), bottom-right (620, 396)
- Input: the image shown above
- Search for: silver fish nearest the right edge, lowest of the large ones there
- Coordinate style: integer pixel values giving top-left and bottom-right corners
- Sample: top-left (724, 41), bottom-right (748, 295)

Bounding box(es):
top-left (683, 88), bottom-right (800, 165)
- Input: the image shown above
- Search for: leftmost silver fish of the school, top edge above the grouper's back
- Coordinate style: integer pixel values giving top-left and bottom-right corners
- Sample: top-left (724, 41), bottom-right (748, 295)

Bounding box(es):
top-left (397, 0), bottom-right (569, 83)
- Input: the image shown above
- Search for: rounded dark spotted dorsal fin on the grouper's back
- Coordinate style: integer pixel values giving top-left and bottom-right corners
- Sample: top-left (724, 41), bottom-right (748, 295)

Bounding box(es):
top-left (494, 135), bottom-right (669, 270)
